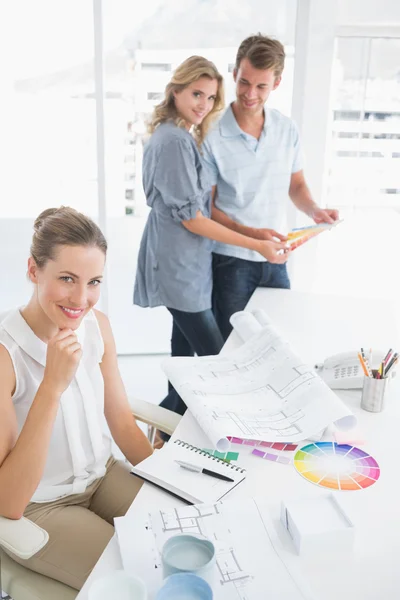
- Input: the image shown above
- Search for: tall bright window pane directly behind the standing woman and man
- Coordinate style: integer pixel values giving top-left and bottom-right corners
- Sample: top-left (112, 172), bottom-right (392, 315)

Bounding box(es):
top-left (103, 0), bottom-right (296, 353)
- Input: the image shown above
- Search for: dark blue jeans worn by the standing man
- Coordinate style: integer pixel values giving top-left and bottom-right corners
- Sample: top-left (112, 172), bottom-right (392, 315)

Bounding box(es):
top-left (213, 253), bottom-right (290, 340)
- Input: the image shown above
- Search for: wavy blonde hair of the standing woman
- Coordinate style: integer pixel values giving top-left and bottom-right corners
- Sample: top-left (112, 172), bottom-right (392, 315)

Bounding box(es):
top-left (148, 56), bottom-right (224, 146)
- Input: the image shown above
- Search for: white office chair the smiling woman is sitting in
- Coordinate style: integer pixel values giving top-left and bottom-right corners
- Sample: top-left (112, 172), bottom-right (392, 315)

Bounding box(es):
top-left (0, 398), bottom-right (181, 600)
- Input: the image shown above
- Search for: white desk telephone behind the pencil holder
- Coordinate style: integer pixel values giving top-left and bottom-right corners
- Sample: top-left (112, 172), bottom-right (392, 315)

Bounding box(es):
top-left (315, 350), bottom-right (385, 390)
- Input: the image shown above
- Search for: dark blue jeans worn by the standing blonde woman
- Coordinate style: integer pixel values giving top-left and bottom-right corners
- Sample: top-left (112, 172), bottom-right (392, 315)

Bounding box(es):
top-left (160, 308), bottom-right (224, 420)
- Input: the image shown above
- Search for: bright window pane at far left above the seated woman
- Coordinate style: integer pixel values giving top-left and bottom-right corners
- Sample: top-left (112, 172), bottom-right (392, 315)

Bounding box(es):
top-left (0, 0), bottom-right (98, 312)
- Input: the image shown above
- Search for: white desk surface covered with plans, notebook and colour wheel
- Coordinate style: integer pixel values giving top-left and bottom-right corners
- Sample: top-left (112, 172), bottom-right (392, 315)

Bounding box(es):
top-left (77, 289), bottom-right (400, 600)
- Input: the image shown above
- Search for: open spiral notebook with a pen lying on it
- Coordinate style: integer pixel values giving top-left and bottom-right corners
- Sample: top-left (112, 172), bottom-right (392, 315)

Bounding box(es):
top-left (132, 440), bottom-right (246, 504)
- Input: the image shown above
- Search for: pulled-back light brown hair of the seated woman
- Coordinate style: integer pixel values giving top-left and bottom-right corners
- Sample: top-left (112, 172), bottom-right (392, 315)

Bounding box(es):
top-left (31, 206), bottom-right (107, 268)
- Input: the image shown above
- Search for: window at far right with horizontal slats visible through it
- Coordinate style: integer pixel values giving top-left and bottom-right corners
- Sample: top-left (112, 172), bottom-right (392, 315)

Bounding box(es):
top-left (327, 37), bottom-right (400, 210)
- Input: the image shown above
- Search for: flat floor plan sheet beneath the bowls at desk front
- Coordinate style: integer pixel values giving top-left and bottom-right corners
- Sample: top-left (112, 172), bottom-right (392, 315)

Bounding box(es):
top-left (114, 498), bottom-right (312, 600)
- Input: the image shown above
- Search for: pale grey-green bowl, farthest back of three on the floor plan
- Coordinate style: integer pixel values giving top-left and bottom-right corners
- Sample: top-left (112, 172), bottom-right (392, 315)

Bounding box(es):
top-left (161, 534), bottom-right (216, 585)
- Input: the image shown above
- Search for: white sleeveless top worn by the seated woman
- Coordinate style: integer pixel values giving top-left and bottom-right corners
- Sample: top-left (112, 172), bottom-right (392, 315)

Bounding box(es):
top-left (0, 309), bottom-right (111, 502)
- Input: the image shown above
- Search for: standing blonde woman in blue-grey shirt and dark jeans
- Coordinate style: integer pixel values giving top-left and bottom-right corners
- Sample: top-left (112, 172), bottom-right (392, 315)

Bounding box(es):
top-left (134, 56), bottom-right (287, 422)
